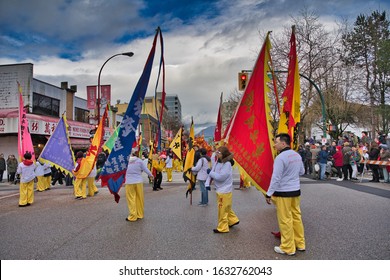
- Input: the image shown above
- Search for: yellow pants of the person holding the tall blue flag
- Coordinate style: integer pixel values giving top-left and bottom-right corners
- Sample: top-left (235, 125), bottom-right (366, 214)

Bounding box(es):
top-left (125, 183), bottom-right (144, 222)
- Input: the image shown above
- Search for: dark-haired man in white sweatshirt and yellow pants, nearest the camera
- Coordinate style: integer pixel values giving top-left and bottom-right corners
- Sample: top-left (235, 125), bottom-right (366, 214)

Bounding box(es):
top-left (266, 133), bottom-right (305, 255)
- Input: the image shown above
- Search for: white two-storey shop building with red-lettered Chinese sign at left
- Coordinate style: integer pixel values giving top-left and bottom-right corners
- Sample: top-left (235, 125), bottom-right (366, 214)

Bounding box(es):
top-left (0, 63), bottom-right (112, 164)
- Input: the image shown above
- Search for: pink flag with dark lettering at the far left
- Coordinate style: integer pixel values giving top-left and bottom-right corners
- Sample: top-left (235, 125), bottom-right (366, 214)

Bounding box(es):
top-left (17, 82), bottom-right (35, 161)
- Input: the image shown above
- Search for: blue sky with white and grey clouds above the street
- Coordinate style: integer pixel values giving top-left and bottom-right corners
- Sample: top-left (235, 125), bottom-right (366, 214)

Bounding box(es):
top-left (0, 0), bottom-right (390, 127)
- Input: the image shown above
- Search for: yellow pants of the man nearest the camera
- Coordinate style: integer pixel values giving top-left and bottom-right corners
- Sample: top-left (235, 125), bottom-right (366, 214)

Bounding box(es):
top-left (272, 196), bottom-right (306, 254)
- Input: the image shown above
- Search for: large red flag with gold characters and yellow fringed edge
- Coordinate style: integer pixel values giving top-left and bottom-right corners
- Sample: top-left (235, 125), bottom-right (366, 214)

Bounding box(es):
top-left (225, 32), bottom-right (275, 193)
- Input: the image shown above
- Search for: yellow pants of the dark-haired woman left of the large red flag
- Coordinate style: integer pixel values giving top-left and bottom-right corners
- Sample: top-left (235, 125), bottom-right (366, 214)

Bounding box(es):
top-left (217, 193), bottom-right (239, 232)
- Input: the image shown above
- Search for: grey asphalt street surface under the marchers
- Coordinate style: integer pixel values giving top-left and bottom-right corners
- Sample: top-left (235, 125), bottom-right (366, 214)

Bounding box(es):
top-left (0, 168), bottom-right (390, 260)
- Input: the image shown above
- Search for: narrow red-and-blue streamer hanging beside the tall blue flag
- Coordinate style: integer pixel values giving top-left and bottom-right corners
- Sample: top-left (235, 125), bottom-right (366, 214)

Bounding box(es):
top-left (155, 27), bottom-right (166, 151)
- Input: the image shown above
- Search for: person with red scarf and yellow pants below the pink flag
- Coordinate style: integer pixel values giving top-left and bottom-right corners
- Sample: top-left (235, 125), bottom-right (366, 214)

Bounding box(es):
top-left (16, 152), bottom-right (36, 207)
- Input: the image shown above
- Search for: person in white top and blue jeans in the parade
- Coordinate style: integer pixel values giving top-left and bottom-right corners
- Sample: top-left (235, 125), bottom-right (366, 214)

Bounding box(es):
top-left (191, 148), bottom-right (211, 206)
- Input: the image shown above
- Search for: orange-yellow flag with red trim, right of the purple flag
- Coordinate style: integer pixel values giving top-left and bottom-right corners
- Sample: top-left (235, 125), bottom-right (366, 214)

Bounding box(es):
top-left (73, 105), bottom-right (109, 179)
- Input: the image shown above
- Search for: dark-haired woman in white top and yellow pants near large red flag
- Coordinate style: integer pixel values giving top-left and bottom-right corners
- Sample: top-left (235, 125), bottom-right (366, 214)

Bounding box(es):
top-left (207, 146), bottom-right (240, 233)
